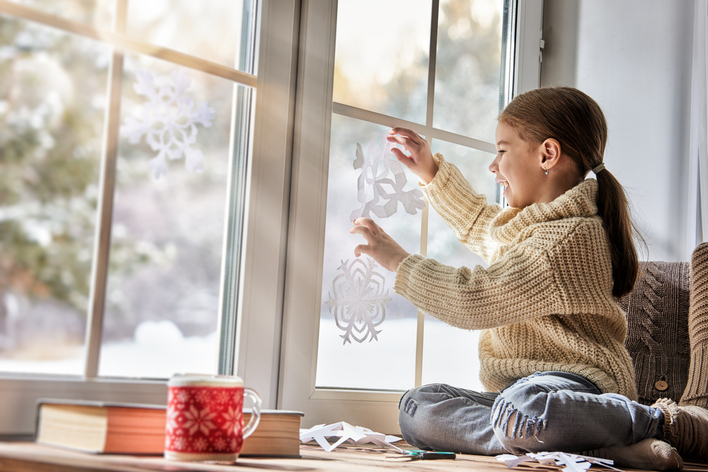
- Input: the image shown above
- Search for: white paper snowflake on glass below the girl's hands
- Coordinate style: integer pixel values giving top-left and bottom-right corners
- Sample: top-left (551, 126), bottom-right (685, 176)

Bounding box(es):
top-left (327, 258), bottom-right (391, 344)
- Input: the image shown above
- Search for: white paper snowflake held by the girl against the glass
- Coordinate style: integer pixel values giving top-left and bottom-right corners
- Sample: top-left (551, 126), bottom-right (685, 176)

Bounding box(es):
top-left (351, 133), bottom-right (425, 221)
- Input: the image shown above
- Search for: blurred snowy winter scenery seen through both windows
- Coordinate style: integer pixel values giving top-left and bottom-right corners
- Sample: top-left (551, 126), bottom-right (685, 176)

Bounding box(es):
top-left (0, 0), bottom-right (503, 389)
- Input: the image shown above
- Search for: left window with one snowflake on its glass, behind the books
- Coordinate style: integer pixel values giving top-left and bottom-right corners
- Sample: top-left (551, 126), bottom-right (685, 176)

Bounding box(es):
top-left (0, 0), bottom-right (274, 433)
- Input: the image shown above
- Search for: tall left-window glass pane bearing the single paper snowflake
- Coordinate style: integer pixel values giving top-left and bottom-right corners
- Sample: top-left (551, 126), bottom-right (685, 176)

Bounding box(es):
top-left (99, 55), bottom-right (240, 378)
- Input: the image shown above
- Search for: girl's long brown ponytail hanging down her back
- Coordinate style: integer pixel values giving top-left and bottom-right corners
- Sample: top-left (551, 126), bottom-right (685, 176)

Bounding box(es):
top-left (596, 169), bottom-right (639, 298)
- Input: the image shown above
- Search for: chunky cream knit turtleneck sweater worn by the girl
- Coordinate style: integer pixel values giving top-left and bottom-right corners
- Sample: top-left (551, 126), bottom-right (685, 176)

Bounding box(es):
top-left (395, 154), bottom-right (637, 400)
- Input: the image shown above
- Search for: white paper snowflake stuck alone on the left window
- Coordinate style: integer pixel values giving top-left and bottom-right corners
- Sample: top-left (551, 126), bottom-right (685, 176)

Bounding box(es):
top-left (121, 69), bottom-right (216, 178)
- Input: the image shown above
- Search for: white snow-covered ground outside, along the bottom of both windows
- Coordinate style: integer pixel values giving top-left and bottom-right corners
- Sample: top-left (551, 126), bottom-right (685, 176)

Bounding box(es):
top-left (0, 318), bottom-right (482, 390)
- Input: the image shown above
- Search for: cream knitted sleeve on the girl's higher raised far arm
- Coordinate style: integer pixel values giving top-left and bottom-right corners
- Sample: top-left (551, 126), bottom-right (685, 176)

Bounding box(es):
top-left (422, 154), bottom-right (501, 263)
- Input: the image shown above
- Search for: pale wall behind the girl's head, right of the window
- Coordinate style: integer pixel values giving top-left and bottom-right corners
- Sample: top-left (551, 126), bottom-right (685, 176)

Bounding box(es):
top-left (541, 0), bottom-right (694, 261)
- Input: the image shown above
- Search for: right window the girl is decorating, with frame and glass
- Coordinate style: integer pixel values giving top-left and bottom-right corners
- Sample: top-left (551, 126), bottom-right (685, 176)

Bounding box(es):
top-left (279, 0), bottom-right (541, 432)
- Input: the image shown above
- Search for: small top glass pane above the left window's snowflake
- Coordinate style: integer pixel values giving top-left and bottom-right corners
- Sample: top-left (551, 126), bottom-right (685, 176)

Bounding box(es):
top-left (128, 0), bottom-right (248, 72)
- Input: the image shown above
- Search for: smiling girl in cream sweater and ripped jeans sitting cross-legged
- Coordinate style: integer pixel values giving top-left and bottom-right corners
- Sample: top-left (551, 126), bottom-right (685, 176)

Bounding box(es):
top-left (351, 87), bottom-right (708, 470)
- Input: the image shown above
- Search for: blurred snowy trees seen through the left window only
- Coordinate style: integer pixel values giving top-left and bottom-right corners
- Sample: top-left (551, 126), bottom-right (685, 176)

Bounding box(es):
top-left (0, 0), bottom-right (243, 378)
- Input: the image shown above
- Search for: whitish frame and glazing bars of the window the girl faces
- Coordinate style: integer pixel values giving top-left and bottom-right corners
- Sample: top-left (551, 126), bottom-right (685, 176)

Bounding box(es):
top-left (278, 0), bottom-right (543, 433)
